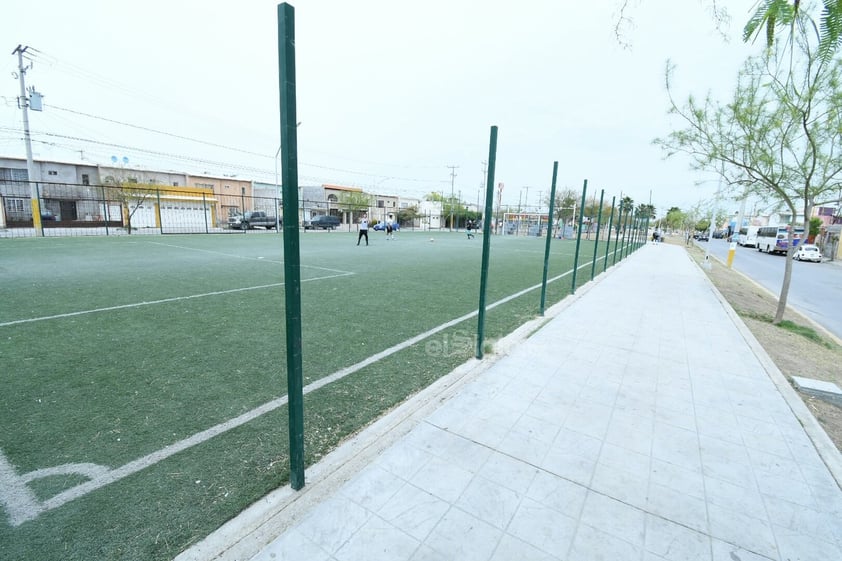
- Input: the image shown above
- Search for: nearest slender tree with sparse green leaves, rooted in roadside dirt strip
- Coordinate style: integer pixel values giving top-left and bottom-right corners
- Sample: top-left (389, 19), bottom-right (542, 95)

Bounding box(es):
top-left (654, 17), bottom-right (842, 323)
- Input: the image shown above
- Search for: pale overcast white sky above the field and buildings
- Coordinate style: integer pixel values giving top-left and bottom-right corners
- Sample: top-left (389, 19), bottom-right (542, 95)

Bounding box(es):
top-left (0, 0), bottom-right (758, 215)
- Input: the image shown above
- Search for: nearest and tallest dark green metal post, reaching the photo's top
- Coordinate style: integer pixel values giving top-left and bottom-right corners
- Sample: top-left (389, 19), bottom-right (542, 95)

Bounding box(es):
top-left (278, 3), bottom-right (304, 490)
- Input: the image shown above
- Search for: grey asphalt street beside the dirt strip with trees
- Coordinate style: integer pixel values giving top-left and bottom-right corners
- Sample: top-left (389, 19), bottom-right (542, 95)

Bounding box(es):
top-left (694, 239), bottom-right (842, 339)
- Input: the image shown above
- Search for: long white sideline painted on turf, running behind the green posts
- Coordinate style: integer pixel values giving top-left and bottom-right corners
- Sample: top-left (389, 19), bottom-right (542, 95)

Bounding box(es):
top-left (0, 252), bottom-right (608, 526)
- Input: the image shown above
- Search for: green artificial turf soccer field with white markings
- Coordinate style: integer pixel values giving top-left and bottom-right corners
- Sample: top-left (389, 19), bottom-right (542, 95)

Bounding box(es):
top-left (0, 231), bottom-right (636, 561)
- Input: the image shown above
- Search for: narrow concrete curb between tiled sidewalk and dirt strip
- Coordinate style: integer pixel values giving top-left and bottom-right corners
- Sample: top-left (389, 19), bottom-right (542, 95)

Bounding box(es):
top-left (687, 253), bottom-right (842, 489)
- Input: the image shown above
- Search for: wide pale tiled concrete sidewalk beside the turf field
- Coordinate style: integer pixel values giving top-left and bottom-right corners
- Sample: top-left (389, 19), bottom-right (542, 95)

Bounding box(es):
top-left (185, 244), bottom-right (842, 561)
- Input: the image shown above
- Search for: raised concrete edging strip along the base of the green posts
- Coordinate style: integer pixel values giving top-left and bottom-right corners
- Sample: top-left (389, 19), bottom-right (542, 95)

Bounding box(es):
top-left (173, 259), bottom-right (626, 561)
